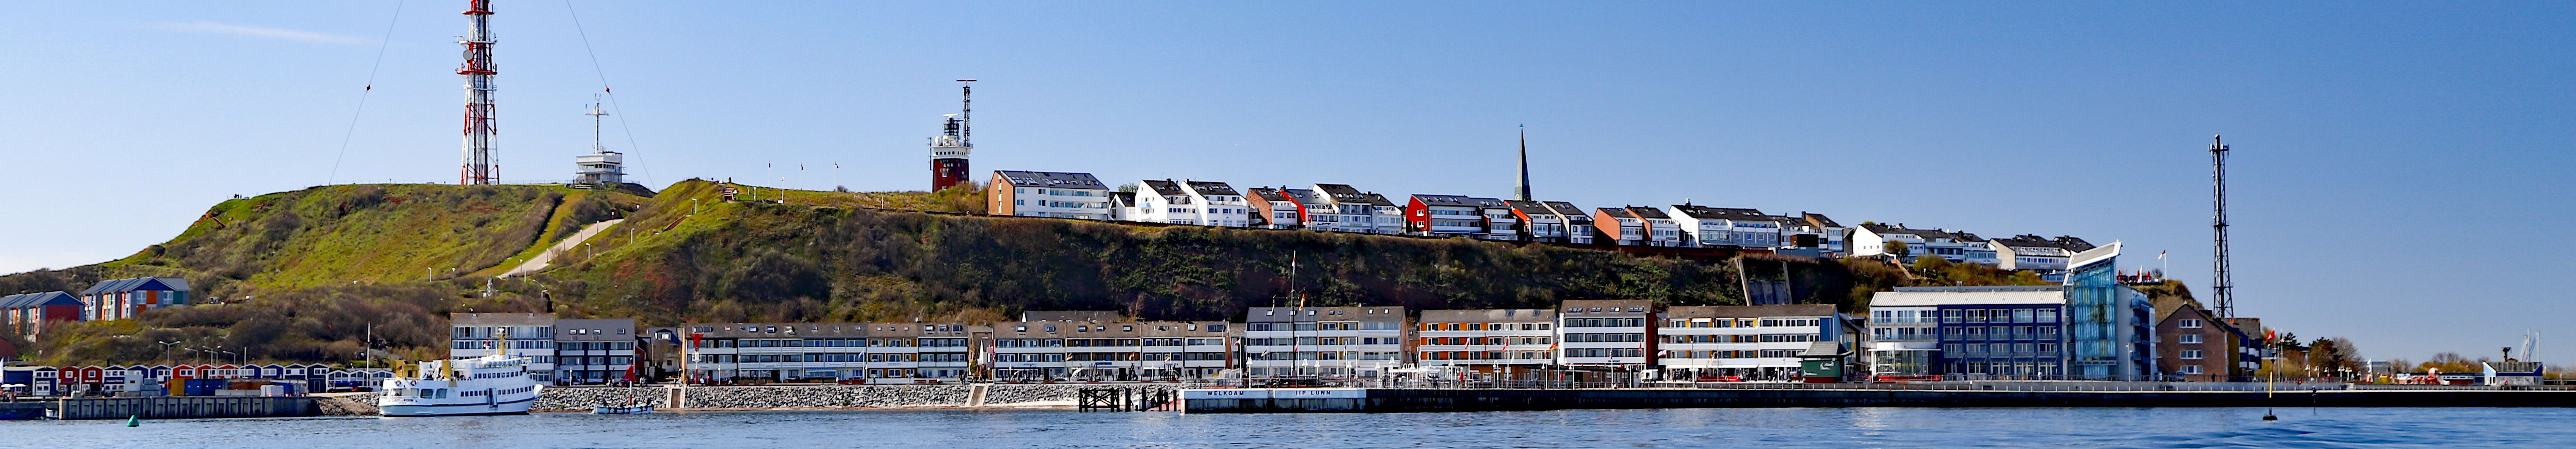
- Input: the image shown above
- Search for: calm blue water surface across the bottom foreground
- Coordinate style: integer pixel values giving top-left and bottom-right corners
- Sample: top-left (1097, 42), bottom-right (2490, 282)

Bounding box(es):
top-left (0, 408), bottom-right (2576, 449)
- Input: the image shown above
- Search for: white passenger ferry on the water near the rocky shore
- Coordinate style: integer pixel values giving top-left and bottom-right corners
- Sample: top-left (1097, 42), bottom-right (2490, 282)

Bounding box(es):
top-left (376, 353), bottom-right (544, 415)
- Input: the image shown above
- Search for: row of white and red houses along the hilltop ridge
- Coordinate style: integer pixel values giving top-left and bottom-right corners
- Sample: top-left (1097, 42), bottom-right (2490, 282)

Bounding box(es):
top-left (986, 170), bottom-right (2094, 276)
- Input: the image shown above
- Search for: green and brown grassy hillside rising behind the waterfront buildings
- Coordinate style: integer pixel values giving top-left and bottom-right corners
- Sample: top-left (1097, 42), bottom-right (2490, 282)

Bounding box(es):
top-left (0, 180), bottom-right (1904, 364)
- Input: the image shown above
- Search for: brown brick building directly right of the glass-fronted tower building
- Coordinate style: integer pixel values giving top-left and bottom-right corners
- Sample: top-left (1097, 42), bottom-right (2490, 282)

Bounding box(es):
top-left (2156, 299), bottom-right (2262, 382)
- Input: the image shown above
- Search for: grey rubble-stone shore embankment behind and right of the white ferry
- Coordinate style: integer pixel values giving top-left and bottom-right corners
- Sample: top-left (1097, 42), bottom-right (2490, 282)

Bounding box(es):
top-left (325, 384), bottom-right (1177, 415)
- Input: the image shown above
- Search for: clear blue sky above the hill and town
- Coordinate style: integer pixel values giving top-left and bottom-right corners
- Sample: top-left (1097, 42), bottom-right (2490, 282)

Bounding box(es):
top-left (0, 0), bottom-right (2576, 361)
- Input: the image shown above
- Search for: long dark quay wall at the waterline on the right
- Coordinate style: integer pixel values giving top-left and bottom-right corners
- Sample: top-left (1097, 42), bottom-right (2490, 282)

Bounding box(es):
top-left (1182, 387), bottom-right (2576, 413)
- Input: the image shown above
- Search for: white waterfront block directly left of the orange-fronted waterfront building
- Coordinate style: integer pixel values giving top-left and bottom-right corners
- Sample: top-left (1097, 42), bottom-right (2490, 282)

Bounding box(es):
top-left (1241, 307), bottom-right (1412, 377)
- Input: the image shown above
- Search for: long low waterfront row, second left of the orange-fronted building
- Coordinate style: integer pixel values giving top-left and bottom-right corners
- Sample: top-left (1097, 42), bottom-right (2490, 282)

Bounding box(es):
top-left (992, 312), bottom-right (1231, 379)
